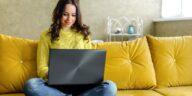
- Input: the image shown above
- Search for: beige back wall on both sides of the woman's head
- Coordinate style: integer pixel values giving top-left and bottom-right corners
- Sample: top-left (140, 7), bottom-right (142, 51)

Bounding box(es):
top-left (0, 0), bottom-right (161, 40)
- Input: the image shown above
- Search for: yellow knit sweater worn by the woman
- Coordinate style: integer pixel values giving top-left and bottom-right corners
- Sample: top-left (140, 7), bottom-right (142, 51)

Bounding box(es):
top-left (37, 29), bottom-right (91, 79)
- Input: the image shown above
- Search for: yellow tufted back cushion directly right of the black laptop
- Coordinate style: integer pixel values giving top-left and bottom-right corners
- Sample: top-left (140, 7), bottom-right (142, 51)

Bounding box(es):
top-left (93, 37), bottom-right (156, 89)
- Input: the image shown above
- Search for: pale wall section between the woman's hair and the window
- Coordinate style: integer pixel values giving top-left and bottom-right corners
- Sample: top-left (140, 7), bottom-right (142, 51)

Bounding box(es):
top-left (80, 0), bottom-right (161, 40)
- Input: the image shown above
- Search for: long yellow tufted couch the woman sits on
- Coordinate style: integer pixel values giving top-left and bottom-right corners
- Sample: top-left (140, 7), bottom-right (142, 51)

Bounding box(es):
top-left (0, 34), bottom-right (192, 96)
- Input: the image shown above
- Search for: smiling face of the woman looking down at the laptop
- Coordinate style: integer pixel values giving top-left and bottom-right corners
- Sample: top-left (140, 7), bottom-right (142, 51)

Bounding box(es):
top-left (61, 4), bottom-right (76, 28)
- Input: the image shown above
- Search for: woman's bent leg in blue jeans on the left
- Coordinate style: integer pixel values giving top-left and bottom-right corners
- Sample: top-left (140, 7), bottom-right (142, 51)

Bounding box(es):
top-left (24, 78), bottom-right (68, 96)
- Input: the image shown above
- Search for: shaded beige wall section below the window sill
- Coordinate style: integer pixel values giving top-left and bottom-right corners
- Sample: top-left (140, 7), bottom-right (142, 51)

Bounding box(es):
top-left (155, 20), bottom-right (192, 36)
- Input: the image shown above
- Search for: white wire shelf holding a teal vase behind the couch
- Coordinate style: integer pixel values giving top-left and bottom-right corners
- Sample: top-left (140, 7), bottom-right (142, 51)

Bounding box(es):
top-left (106, 16), bottom-right (143, 41)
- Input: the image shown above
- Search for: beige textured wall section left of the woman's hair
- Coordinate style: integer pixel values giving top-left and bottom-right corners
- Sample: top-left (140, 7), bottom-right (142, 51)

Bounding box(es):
top-left (0, 0), bottom-right (56, 39)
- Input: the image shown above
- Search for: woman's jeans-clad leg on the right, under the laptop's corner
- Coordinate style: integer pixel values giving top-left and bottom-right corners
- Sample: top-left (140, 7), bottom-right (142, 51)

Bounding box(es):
top-left (80, 80), bottom-right (117, 96)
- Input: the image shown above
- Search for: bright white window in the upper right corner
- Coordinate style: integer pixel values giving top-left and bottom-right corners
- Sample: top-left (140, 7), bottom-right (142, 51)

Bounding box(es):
top-left (161, 0), bottom-right (192, 18)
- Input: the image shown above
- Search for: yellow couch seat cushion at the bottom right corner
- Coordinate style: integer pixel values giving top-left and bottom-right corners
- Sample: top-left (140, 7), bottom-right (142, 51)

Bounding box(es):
top-left (155, 86), bottom-right (192, 96)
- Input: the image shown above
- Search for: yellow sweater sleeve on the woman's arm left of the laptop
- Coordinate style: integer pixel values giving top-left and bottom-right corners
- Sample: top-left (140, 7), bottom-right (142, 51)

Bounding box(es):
top-left (37, 32), bottom-right (50, 79)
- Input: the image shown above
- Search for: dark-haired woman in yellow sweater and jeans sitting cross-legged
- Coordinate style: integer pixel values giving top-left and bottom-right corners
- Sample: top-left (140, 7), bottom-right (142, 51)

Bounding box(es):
top-left (24, 0), bottom-right (117, 96)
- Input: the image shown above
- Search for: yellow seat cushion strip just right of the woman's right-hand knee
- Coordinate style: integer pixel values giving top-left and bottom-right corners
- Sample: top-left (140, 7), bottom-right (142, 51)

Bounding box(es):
top-left (117, 90), bottom-right (163, 96)
